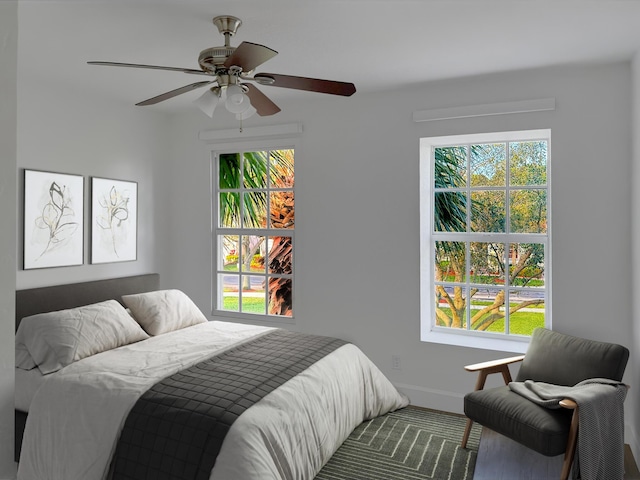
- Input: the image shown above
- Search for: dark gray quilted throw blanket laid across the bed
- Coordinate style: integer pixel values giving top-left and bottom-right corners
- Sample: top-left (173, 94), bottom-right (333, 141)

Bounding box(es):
top-left (112, 329), bottom-right (346, 480)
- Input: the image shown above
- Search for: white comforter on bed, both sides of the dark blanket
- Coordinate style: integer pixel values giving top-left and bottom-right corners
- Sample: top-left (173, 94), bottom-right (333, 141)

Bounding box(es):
top-left (18, 322), bottom-right (408, 480)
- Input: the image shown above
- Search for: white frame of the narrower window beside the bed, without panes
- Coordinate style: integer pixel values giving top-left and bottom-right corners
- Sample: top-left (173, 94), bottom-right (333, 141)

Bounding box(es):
top-left (210, 138), bottom-right (301, 324)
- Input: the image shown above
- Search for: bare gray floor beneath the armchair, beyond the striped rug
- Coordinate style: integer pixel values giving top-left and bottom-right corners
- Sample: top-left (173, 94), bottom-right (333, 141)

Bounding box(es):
top-left (473, 428), bottom-right (640, 480)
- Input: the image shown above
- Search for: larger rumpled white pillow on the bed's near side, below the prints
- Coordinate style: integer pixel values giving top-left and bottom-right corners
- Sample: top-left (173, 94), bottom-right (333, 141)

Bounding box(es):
top-left (16, 300), bottom-right (149, 375)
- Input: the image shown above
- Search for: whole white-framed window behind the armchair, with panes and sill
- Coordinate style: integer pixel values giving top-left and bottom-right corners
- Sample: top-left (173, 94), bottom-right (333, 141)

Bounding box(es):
top-left (421, 130), bottom-right (551, 351)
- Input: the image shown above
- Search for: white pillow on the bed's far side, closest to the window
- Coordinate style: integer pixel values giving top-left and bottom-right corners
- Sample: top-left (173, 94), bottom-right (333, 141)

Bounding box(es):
top-left (122, 290), bottom-right (207, 335)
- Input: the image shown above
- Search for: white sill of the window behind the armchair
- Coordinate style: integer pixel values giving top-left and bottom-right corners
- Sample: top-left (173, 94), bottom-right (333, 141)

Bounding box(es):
top-left (420, 328), bottom-right (530, 353)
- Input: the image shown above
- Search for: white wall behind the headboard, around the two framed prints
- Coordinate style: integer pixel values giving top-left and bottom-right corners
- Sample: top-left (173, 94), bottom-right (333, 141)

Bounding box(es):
top-left (17, 70), bottom-right (168, 289)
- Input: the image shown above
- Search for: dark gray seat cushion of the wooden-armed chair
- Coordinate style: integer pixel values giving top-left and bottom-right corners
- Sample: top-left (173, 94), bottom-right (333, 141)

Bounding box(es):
top-left (464, 386), bottom-right (572, 456)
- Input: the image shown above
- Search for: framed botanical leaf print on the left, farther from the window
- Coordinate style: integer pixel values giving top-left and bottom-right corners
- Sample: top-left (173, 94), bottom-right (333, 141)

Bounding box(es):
top-left (23, 169), bottom-right (84, 270)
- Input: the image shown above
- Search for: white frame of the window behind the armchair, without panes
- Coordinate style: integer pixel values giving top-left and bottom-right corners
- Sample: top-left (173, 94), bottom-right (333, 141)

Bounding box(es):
top-left (420, 129), bottom-right (552, 353)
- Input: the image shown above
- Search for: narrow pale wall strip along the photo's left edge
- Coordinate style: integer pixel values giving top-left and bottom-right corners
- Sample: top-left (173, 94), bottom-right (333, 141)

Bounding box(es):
top-left (0, 1), bottom-right (18, 479)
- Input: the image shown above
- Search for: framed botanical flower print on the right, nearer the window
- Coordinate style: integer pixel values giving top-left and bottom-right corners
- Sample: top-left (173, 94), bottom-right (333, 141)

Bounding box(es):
top-left (91, 177), bottom-right (138, 263)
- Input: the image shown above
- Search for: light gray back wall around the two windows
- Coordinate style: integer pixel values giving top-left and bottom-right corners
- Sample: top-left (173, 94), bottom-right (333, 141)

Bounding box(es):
top-left (165, 63), bottom-right (638, 446)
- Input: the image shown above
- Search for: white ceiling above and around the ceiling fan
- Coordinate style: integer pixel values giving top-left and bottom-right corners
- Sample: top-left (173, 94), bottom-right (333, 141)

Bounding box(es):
top-left (18, 0), bottom-right (640, 111)
